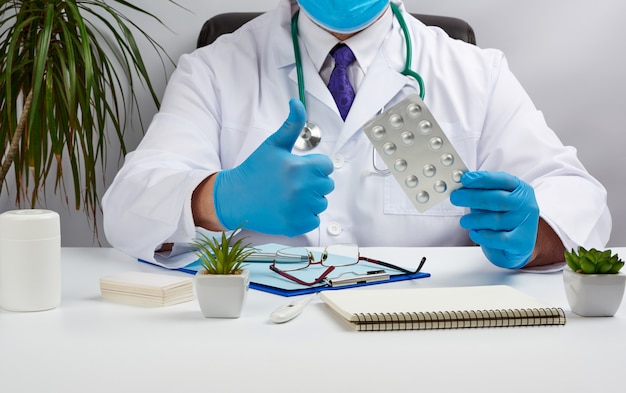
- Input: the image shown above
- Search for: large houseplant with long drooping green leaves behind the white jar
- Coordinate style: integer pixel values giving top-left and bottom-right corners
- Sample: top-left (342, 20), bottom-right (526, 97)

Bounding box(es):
top-left (0, 0), bottom-right (175, 228)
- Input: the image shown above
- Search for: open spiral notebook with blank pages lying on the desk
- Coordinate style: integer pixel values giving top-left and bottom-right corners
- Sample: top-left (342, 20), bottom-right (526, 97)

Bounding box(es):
top-left (320, 285), bottom-right (565, 331)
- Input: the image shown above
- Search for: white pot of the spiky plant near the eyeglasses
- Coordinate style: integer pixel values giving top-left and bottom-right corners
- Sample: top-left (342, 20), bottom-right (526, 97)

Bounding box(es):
top-left (194, 269), bottom-right (250, 318)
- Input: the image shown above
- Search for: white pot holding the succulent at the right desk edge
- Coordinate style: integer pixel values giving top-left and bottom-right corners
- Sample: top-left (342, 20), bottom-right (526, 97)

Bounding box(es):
top-left (563, 266), bottom-right (626, 317)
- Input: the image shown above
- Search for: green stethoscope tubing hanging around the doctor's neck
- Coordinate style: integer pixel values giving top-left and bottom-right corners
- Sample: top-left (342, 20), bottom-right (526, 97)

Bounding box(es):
top-left (291, 3), bottom-right (426, 113)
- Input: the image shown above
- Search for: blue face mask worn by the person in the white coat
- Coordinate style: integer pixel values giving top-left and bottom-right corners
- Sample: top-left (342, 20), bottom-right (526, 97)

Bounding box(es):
top-left (298, 0), bottom-right (389, 34)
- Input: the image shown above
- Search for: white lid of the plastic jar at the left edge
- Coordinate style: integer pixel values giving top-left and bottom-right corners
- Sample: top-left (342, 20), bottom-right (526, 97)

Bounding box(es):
top-left (0, 209), bottom-right (61, 240)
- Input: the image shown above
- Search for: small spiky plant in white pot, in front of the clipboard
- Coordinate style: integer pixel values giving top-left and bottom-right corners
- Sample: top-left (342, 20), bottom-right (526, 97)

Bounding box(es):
top-left (191, 230), bottom-right (256, 318)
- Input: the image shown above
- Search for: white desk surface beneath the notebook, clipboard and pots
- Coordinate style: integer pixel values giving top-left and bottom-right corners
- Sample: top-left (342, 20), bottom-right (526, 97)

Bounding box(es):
top-left (0, 247), bottom-right (626, 393)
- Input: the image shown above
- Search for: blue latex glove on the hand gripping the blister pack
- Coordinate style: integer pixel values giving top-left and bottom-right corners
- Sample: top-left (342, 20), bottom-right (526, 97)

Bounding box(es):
top-left (450, 171), bottom-right (539, 269)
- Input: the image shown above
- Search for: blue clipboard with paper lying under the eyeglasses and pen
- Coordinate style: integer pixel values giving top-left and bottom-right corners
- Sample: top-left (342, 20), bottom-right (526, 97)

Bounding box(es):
top-left (139, 244), bottom-right (430, 296)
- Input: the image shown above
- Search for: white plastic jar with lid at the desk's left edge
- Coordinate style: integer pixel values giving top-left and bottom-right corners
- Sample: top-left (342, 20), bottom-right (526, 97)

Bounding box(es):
top-left (0, 209), bottom-right (61, 311)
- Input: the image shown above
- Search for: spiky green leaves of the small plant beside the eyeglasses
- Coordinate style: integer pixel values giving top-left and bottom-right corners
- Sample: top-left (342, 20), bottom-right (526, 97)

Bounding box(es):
top-left (190, 230), bottom-right (256, 274)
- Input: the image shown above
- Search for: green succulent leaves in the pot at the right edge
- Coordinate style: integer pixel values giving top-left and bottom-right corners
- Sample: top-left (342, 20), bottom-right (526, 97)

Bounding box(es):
top-left (565, 247), bottom-right (624, 274)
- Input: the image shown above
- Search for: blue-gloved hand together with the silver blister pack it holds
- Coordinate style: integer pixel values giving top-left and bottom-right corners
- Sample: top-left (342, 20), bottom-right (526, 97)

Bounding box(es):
top-left (363, 95), bottom-right (539, 269)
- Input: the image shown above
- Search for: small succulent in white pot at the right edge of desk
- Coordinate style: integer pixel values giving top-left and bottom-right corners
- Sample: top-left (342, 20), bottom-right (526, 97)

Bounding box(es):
top-left (563, 247), bottom-right (626, 317)
